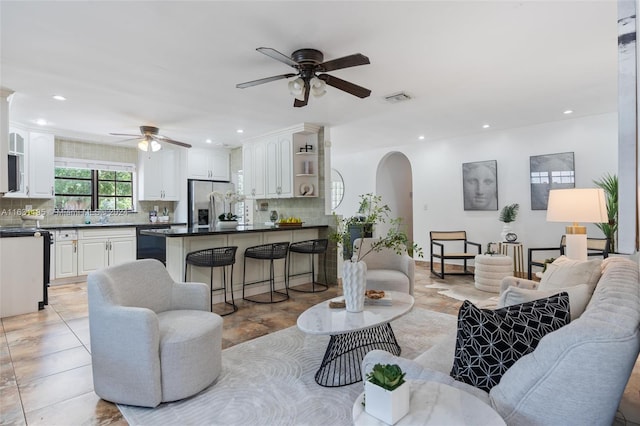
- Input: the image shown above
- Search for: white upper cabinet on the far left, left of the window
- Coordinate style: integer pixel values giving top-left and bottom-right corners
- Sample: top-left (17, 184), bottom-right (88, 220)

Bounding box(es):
top-left (4, 128), bottom-right (55, 198)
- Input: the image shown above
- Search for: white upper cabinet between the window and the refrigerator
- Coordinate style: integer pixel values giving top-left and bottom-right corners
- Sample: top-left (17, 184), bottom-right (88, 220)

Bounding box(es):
top-left (138, 147), bottom-right (180, 201)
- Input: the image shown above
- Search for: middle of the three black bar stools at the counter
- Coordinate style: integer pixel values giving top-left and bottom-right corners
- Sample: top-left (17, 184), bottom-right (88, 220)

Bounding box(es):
top-left (242, 241), bottom-right (289, 303)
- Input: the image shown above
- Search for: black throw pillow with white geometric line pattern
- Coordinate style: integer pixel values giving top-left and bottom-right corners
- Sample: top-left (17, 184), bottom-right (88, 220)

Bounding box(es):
top-left (451, 292), bottom-right (571, 392)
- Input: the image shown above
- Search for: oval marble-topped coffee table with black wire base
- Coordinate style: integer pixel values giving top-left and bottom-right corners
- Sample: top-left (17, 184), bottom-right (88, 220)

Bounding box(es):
top-left (298, 291), bottom-right (414, 387)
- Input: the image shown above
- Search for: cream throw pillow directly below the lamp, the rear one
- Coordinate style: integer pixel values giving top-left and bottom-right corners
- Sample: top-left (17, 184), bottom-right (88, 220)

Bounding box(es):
top-left (538, 256), bottom-right (602, 293)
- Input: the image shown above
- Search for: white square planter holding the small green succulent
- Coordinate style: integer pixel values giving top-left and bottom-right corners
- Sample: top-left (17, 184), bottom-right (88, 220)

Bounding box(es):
top-left (364, 380), bottom-right (411, 425)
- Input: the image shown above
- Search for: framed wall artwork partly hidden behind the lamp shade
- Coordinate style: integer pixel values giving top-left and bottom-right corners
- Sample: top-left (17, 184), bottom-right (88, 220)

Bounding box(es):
top-left (529, 152), bottom-right (576, 210)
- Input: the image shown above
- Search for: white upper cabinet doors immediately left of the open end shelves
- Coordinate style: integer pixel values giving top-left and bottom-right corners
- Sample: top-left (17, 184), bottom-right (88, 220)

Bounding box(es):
top-left (265, 133), bottom-right (293, 198)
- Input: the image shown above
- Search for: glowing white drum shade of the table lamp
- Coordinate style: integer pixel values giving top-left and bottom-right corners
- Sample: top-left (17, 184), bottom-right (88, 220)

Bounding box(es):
top-left (547, 188), bottom-right (609, 223)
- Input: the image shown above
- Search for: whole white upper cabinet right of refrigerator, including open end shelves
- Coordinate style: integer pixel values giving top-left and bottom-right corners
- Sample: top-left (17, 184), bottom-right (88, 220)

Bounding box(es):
top-left (242, 123), bottom-right (320, 198)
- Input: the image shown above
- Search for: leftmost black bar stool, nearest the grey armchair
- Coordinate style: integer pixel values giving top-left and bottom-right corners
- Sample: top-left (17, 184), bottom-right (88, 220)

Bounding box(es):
top-left (184, 246), bottom-right (238, 316)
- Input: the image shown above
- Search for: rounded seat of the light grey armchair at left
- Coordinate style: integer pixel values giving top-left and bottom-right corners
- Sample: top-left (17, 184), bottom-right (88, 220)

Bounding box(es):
top-left (158, 310), bottom-right (222, 402)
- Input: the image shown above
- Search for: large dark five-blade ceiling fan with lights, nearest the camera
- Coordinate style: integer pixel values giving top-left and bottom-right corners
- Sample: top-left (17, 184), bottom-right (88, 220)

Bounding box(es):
top-left (236, 47), bottom-right (371, 107)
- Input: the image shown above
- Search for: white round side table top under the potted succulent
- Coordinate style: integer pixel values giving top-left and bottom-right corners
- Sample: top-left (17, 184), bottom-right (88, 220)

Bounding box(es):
top-left (352, 380), bottom-right (505, 426)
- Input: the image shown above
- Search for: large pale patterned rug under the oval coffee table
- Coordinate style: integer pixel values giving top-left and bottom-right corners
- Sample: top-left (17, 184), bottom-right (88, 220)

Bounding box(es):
top-left (118, 308), bottom-right (456, 426)
